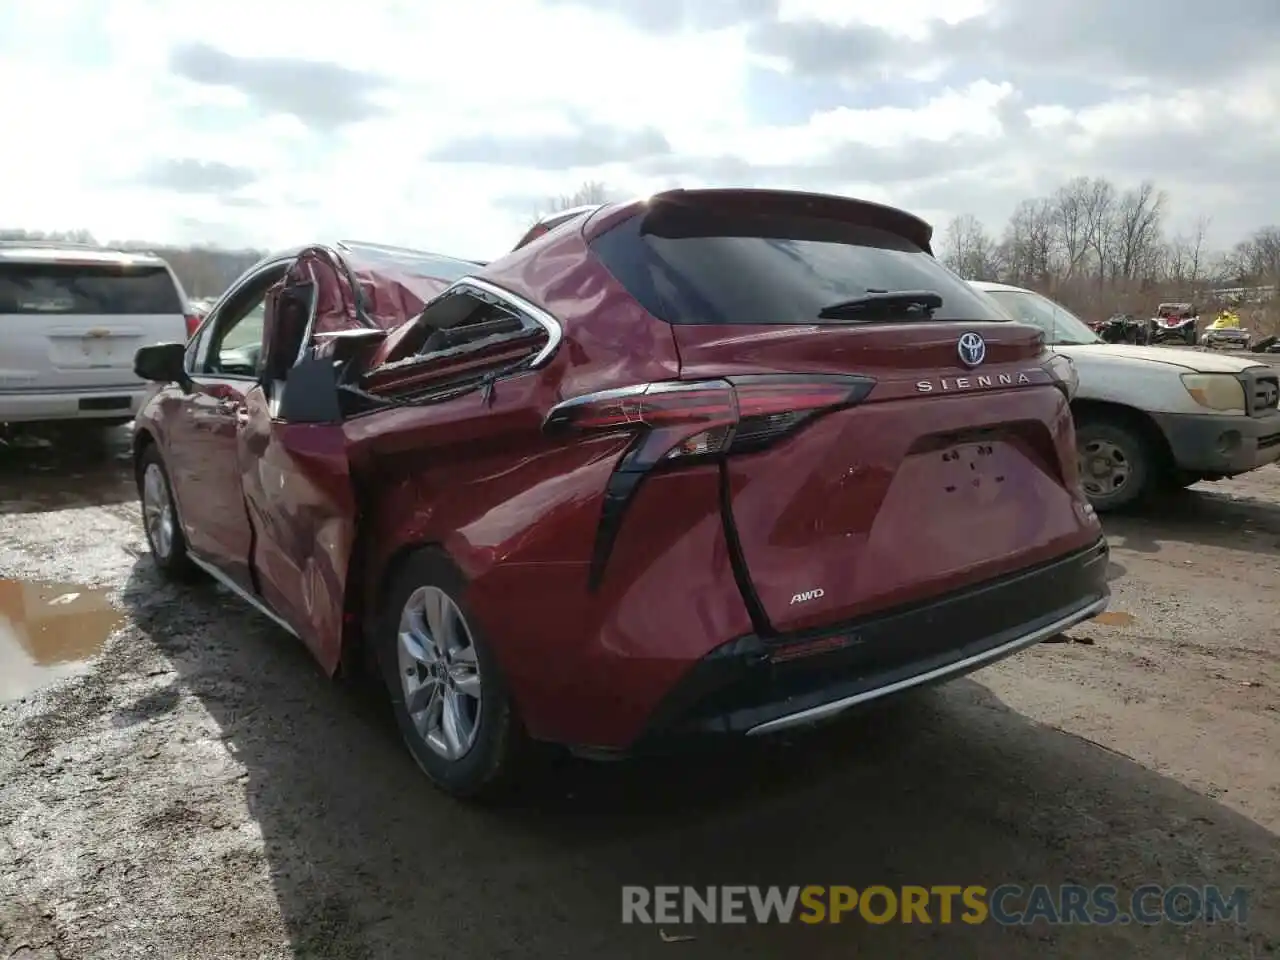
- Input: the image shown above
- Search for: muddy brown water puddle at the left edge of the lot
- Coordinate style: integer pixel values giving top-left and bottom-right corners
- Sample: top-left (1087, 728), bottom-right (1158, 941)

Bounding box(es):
top-left (0, 580), bottom-right (124, 701)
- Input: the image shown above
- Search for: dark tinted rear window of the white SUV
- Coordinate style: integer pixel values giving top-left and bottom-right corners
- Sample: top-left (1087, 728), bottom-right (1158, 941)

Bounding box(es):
top-left (0, 262), bottom-right (183, 315)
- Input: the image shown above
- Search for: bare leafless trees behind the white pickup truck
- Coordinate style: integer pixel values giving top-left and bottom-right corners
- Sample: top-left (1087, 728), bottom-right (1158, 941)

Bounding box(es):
top-left (937, 177), bottom-right (1280, 325)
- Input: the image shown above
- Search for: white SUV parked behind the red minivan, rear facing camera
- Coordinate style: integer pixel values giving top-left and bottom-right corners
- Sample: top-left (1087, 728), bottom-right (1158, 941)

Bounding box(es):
top-left (0, 241), bottom-right (193, 425)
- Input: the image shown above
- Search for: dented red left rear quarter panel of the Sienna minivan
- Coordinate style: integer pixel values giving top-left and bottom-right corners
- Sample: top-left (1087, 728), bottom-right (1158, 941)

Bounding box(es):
top-left (343, 230), bottom-right (750, 745)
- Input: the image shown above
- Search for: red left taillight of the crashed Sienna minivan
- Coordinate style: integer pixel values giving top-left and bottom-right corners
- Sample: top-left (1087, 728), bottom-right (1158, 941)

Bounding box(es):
top-left (544, 374), bottom-right (876, 590)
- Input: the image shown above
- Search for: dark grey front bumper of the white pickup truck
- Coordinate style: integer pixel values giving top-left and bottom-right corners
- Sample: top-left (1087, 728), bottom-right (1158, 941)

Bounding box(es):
top-left (1152, 413), bottom-right (1280, 476)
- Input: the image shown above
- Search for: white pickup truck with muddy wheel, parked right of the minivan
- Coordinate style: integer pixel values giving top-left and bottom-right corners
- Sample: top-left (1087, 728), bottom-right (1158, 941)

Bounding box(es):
top-left (969, 280), bottom-right (1280, 512)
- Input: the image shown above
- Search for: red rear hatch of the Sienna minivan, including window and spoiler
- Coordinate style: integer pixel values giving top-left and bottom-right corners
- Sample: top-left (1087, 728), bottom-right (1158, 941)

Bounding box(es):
top-left (593, 191), bottom-right (1097, 634)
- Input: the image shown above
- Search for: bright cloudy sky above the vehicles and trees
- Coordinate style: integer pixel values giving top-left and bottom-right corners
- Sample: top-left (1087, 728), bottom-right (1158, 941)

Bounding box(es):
top-left (0, 0), bottom-right (1280, 257)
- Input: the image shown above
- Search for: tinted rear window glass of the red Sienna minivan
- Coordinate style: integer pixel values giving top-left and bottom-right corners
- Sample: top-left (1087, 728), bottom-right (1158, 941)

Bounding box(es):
top-left (591, 211), bottom-right (1009, 324)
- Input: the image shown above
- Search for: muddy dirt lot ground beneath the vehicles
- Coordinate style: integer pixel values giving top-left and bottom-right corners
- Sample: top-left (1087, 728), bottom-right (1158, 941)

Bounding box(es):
top-left (0, 430), bottom-right (1280, 960)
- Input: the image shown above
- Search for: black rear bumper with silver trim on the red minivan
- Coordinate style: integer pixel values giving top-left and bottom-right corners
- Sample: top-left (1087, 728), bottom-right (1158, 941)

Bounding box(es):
top-left (635, 539), bottom-right (1110, 751)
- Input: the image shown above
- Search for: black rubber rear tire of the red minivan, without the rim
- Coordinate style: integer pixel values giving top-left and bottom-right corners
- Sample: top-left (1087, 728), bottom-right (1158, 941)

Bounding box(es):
top-left (375, 549), bottom-right (532, 800)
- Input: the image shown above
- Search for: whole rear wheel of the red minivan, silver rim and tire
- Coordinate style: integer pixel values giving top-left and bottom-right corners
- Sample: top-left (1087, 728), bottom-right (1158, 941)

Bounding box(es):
top-left (378, 550), bottom-right (527, 800)
